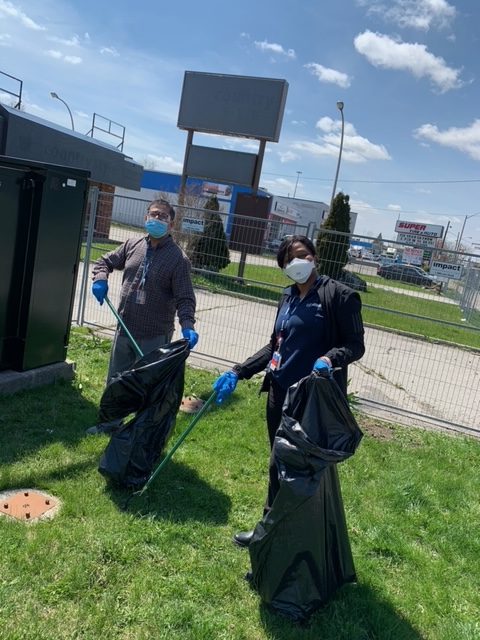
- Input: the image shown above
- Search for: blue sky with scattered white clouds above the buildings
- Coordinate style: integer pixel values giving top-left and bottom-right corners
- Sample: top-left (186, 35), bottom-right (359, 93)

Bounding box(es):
top-left (0, 0), bottom-right (480, 252)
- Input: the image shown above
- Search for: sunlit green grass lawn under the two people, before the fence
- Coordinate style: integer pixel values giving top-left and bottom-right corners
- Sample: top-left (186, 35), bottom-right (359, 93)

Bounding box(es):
top-left (0, 330), bottom-right (480, 640)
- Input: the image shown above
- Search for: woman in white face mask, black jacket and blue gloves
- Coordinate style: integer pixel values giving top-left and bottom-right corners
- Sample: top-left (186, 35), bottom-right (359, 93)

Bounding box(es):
top-left (213, 236), bottom-right (365, 547)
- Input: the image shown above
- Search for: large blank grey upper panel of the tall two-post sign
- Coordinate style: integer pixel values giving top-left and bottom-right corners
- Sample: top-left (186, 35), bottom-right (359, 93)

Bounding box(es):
top-left (177, 71), bottom-right (288, 142)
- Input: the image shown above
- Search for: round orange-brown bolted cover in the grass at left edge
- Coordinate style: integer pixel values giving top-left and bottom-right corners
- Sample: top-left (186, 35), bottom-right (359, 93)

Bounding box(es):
top-left (0, 489), bottom-right (60, 522)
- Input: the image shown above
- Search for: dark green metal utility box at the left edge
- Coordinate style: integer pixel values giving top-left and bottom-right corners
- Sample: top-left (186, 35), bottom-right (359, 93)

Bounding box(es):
top-left (0, 156), bottom-right (90, 371)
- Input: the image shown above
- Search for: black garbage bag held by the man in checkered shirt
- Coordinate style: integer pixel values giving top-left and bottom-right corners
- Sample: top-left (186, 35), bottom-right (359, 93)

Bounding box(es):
top-left (98, 340), bottom-right (190, 489)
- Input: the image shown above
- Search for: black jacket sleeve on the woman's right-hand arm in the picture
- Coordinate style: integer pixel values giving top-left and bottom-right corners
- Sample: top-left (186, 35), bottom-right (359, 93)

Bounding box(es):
top-left (324, 287), bottom-right (365, 367)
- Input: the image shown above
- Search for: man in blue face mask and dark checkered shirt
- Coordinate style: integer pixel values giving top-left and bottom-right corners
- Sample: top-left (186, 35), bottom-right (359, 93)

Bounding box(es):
top-left (87, 200), bottom-right (198, 434)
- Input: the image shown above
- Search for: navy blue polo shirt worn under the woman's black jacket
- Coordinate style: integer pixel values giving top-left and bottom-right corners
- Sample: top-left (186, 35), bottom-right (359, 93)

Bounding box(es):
top-left (271, 279), bottom-right (329, 389)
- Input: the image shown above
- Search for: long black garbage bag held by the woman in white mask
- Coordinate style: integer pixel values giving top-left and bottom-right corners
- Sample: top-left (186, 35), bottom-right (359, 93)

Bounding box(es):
top-left (248, 375), bottom-right (363, 622)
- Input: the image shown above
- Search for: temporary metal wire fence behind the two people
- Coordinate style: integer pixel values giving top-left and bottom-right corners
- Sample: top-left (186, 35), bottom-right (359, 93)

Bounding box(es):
top-left (73, 189), bottom-right (480, 434)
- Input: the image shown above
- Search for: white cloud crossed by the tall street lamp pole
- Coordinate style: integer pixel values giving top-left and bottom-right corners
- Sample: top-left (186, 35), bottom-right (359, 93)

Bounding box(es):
top-left (291, 117), bottom-right (390, 163)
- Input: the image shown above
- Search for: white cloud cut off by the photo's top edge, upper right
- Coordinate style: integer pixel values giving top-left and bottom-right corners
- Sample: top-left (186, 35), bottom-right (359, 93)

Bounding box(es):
top-left (359, 0), bottom-right (456, 31)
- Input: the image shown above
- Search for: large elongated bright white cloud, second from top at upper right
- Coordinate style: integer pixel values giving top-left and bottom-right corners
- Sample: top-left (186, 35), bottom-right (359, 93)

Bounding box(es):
top-left (354, 31), bottom-right (463, 93)
